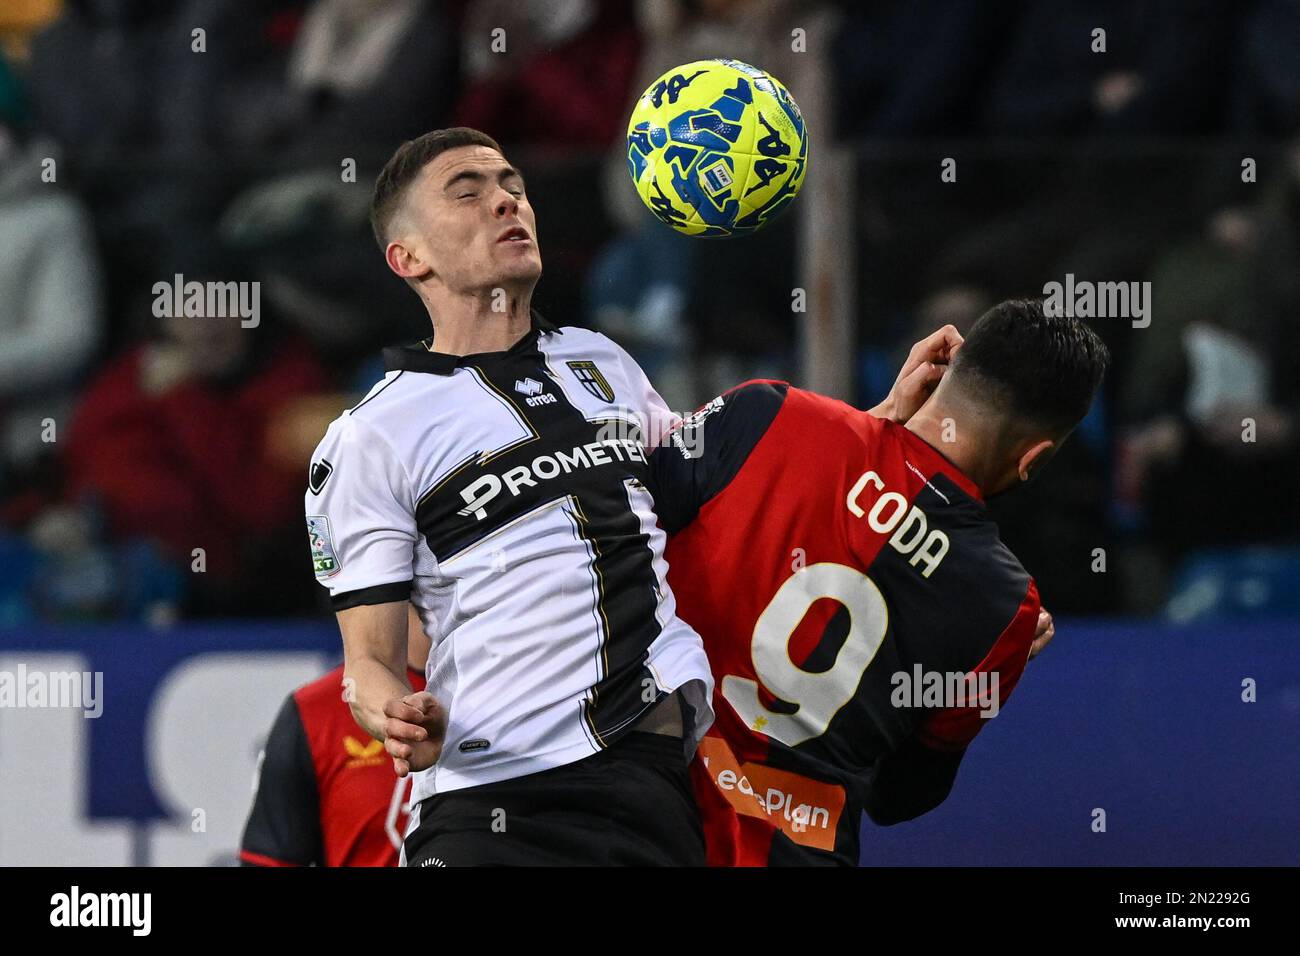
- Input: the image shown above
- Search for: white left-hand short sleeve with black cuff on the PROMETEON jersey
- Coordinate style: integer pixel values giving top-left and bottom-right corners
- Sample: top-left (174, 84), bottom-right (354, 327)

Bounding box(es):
top-left (304, 415), bottom-right (419, 611)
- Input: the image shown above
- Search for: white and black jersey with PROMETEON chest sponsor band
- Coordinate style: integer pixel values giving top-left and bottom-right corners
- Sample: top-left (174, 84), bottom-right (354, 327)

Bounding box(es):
top-left (306, 313), bottom-right (712, 801)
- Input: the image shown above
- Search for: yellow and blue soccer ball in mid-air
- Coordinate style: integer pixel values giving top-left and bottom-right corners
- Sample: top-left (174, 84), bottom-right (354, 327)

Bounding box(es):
top-left (628, 60), bottom-right (809, 237)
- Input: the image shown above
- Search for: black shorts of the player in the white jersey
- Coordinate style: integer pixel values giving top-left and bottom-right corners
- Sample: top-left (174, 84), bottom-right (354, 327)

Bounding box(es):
top-left (403, 731), bottom-right (705, 866)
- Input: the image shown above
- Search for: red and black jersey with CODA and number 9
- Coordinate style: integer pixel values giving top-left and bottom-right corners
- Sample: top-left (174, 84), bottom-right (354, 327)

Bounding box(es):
top-left (651, 381), bottom-right (1039, 865)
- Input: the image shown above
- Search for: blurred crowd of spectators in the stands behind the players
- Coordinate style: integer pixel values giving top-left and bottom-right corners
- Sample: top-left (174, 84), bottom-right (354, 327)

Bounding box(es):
top-left (0, 0), bottom-right (1300, 626)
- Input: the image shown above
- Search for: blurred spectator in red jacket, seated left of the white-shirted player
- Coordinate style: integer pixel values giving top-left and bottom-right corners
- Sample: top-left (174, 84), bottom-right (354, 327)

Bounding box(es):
top-left (68, 297), bottom-right (324, 614)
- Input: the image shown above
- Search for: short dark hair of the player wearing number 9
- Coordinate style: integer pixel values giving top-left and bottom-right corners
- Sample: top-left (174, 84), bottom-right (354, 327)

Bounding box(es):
top-left (949, 299), bottom-right (1110, 432)
